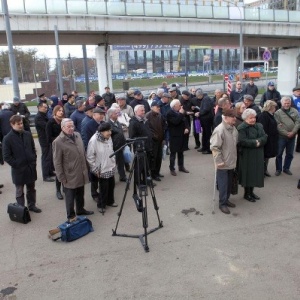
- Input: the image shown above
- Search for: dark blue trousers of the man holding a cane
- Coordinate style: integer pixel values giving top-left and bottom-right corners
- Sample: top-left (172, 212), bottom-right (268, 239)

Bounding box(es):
top-left (217, 169), bottom-right (233, 207)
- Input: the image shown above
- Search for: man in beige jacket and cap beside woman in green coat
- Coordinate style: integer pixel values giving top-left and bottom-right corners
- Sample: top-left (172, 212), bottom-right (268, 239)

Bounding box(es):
top-left (210, 110), bottom-right (238, 214)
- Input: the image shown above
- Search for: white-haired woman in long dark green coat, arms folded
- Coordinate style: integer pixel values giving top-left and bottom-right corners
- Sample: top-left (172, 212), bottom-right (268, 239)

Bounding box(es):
top-left (237, 108), bottom-right (268, 202)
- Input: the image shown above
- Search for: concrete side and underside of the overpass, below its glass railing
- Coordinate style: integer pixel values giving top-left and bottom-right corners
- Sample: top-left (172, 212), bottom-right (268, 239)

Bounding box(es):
top-left (0, 15), bottom-right (300, 47)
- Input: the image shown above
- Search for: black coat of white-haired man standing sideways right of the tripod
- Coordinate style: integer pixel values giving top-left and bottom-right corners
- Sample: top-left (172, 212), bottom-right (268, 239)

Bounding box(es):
top-left (167, 109), bottom-right (189, 152)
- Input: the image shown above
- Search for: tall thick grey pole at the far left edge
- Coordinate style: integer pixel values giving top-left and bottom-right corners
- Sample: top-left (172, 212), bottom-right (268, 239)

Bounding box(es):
top-left (2, 0), bottom-right (20, 98)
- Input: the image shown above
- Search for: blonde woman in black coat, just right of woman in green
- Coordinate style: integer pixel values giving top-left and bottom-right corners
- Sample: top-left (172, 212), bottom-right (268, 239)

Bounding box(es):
top-left (257, 100), bottom-right (278, 177)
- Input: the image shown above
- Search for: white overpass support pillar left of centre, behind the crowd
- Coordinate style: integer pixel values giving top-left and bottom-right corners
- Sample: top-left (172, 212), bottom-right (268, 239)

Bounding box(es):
top-left (95, 44), bottom-right (113, 95)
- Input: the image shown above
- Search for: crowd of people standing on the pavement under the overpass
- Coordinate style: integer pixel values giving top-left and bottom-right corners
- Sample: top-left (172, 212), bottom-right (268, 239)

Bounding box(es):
top-left (0, 81), bottom-right (300, 219)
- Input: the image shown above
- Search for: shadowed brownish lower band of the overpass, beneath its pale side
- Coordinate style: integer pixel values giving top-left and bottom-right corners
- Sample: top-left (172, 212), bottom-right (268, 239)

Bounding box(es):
top-left (0, 31), bottom-right (300, 47)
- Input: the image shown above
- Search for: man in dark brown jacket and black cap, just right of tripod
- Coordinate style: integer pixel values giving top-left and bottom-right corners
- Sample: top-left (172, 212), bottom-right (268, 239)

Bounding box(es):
top-left (145, 101), bottom-right (165, 181)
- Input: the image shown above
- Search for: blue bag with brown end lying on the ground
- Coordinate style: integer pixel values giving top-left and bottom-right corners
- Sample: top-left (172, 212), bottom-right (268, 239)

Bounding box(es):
top-left (48, 216), bottom-right (94, 242)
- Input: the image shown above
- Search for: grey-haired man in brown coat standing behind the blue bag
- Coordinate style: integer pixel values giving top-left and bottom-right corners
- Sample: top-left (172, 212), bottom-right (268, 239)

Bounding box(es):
top-left (52, 118), bottom-right (94, 219)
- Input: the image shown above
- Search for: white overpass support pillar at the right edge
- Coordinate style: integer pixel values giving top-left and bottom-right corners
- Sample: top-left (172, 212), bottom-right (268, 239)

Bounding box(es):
top-left (277, 48), bottom-right (300, 95)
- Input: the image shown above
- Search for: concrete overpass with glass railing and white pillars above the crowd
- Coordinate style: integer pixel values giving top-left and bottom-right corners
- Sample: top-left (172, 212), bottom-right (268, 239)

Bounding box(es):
top-left (0, 0), bottom-right (300, 90)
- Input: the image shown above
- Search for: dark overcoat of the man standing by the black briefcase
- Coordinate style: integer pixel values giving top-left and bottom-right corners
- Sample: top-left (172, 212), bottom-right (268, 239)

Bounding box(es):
top-left (3, 129), bottom-right (37, 185)
